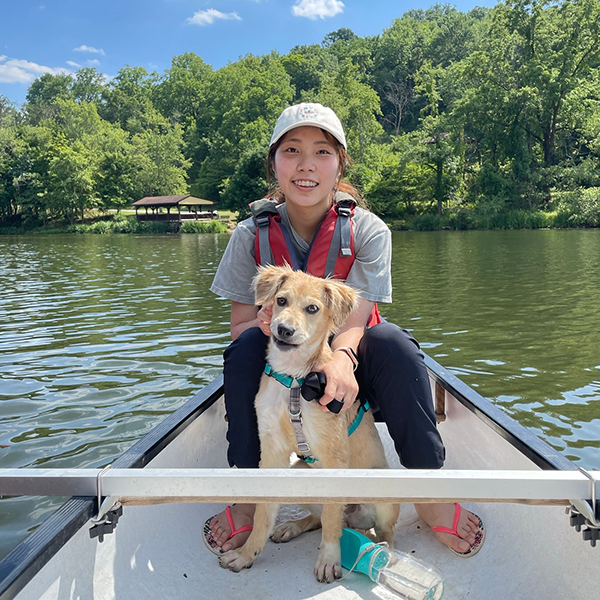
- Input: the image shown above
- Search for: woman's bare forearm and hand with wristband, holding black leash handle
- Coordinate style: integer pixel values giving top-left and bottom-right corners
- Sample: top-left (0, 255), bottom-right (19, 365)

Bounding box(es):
top-left (319, 298), bottom-right (374, 410)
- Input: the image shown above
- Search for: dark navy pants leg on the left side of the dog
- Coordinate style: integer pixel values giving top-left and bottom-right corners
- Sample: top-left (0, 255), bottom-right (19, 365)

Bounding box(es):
top-left (223, 327), bottom-right (269, 469)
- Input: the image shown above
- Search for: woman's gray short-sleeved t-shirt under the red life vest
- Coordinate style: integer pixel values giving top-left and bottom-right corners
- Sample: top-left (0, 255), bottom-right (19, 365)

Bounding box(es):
top-left (210, 203), bottom-right (392, 304)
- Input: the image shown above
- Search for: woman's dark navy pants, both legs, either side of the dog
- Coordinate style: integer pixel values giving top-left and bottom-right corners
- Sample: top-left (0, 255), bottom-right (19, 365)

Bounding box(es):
top-left (223, 323), bottom-right (445, 469)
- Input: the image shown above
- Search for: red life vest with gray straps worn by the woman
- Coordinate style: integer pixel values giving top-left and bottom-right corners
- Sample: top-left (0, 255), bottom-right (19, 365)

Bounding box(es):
top-left (250, 194), bottom-right (381, 327)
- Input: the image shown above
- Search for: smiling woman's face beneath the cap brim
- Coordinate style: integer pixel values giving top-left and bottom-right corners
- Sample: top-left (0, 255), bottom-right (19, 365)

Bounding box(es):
top-left (273, 126), bottom-right (340, 209)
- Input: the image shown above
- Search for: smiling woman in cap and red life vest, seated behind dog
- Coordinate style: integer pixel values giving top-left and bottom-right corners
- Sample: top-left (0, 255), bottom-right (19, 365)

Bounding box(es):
top-left (204, 104), bottom-right (484, 556)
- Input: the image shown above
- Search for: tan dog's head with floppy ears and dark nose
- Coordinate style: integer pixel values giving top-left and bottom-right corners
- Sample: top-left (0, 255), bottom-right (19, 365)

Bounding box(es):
top-left (254, 266), bottom-right (359, 351)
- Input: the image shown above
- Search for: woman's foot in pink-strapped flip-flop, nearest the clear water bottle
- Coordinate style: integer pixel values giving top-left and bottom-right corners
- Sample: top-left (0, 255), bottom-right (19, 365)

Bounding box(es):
top-left (415, 503), bottom-right (480, 553)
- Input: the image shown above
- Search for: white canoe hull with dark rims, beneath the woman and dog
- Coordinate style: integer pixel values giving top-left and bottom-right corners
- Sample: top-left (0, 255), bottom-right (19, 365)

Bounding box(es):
top-left (0, 357), bottom-right (600, 600)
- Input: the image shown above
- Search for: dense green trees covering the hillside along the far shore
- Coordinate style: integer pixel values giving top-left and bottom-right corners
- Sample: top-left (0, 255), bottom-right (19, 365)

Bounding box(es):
top-left (0, 0), bottom-right (600, 227)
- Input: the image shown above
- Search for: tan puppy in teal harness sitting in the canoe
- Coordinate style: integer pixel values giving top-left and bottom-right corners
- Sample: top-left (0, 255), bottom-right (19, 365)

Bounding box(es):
top-left (220, 266), bottom-right (399, 582)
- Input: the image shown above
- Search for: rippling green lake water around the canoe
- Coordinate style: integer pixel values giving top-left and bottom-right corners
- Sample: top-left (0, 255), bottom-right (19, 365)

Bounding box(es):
top-left (0, 230), bottom-right (600, 557)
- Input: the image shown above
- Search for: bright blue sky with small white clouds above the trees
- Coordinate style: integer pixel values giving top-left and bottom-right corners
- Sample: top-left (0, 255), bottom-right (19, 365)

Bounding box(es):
top-left (0, 0), bottom-right (496, 105)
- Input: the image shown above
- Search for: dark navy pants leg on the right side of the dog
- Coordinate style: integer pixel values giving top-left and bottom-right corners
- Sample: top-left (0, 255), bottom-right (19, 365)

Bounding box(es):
top-left (356, 323), bottom-right (445, 469)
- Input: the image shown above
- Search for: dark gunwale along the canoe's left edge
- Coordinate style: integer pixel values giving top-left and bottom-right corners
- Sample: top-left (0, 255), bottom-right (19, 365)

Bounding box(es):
top-left (0, 375), bottom-right (223, 600)
